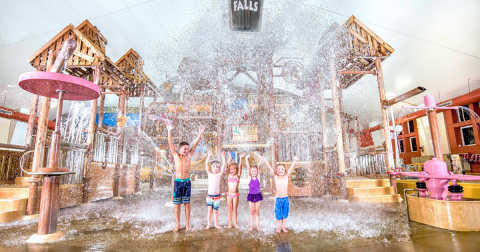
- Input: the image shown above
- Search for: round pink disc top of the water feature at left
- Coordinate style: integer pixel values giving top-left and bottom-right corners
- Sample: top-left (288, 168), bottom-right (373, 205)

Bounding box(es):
top-left (18, 71), bottom-right (100, 101)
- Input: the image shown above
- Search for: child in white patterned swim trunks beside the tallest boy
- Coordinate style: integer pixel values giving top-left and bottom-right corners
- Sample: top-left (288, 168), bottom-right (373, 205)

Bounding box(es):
top-left (205, 150), bottom-right (225, 230)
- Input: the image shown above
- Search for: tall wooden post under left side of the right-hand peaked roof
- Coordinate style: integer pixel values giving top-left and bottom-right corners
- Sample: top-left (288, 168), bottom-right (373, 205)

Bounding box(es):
top-left (330, 54), bottom-right (347, 199)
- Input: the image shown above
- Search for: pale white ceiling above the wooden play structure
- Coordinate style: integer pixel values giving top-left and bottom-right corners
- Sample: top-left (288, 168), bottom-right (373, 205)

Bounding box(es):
top-left (0, 0), bottom-right (480, 127)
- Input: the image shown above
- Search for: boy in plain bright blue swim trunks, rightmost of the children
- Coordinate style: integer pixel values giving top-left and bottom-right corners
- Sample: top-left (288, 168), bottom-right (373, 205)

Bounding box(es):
top-left (263, 155), bottom-right (297, 233)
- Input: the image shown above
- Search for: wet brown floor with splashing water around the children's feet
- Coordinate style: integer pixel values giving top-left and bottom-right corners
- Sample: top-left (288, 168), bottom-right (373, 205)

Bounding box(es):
top-left (0, 182), bottom-right (480, 252)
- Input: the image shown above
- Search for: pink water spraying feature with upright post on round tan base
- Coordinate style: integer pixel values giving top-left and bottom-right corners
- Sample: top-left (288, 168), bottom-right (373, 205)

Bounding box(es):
top-left (388, 95), bottom-right (480, 201)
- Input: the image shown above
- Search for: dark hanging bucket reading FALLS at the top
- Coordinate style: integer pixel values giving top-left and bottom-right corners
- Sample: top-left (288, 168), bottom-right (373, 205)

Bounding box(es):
top-left (230, 0), bottom-right (263, 32)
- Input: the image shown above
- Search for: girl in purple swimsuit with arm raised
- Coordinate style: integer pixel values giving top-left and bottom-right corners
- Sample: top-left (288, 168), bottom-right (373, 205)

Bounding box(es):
top-left (245, 155), bottom-right (263, 231)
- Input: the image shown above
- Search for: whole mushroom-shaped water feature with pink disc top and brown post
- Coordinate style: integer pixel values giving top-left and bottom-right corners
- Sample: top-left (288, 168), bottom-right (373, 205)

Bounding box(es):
top-left (18, 71), bottom-right (100, 243)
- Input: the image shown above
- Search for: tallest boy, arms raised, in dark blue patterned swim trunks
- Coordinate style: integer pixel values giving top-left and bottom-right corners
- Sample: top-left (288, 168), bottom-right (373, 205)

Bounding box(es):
top-left (167, 122), bottom-right (205, 232)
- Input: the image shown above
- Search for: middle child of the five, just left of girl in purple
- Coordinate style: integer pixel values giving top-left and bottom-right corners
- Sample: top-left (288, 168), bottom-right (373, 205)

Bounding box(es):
top-left (225, 154), bottom-right (245, 228)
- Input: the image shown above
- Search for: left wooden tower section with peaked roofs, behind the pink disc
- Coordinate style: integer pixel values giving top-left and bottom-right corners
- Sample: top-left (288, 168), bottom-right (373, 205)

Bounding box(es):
top-left (0, 20), bottom-right (160, 226)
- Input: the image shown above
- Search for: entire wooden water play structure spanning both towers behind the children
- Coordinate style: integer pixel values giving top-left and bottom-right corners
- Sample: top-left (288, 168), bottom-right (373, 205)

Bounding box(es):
top-left (0, 13), bottom-right (406, 228)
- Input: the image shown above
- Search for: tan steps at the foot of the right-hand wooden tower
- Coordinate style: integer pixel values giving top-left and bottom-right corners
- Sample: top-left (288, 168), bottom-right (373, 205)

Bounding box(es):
top-left (346, 179), bottom-right (402, 203)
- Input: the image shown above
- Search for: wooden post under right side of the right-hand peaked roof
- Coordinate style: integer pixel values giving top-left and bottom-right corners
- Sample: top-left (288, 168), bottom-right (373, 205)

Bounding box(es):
top-left (375, 58), bottom-right (397, 193)
